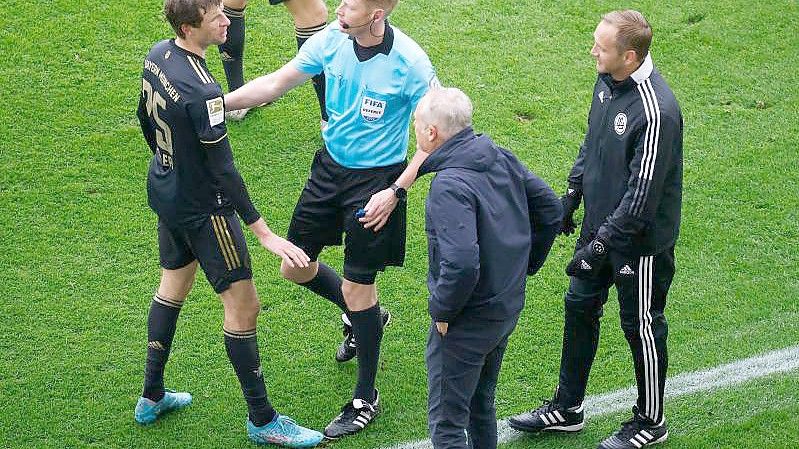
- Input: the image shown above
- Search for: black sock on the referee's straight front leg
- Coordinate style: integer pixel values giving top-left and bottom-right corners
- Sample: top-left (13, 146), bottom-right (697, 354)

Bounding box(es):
top-left (349, 304), bottom-right (383, 403)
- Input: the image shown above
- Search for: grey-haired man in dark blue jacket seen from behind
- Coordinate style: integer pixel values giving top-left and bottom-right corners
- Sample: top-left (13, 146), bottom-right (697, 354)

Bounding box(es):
top-left (414, 88), bottom-right (562, 449)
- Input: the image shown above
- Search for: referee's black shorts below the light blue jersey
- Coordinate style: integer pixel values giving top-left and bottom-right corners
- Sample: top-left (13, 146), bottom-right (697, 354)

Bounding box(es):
top-left (288, 147), bottom-right (407, 285)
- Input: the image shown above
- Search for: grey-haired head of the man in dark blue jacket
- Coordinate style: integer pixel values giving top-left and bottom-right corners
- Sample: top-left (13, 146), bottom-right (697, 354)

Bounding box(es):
top-left (416, 87), bottom-right (473, 140)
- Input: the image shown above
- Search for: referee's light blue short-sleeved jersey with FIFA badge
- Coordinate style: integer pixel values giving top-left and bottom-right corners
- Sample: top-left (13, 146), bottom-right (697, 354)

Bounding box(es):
top-left (293, 21), bottom-right (438, 168)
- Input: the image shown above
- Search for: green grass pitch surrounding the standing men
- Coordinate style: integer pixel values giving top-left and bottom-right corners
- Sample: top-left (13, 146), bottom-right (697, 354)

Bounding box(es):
top-left (0, 0), bottom-right (799, 449)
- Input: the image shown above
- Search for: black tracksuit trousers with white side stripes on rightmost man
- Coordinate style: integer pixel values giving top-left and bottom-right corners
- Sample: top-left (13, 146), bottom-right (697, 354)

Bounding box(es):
top-left (558, 247), bottom-right (674, 423)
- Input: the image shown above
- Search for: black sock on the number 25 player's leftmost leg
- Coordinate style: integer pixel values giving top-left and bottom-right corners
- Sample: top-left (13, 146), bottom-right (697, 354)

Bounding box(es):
top-left (142, 294), bottom-right (182, 402)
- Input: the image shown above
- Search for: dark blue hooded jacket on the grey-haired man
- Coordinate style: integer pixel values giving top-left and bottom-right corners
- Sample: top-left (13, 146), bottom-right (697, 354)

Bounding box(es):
top-left (419, 128), bottom-right (563, 322)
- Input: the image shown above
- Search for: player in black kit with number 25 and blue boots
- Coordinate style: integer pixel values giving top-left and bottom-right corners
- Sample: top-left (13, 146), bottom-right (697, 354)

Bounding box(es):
top-left (134, 0), bottom-right (322, 447)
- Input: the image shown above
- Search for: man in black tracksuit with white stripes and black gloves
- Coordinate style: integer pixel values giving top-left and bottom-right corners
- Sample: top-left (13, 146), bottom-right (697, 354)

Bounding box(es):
top-left (510, 10), bottom-right (683, 449)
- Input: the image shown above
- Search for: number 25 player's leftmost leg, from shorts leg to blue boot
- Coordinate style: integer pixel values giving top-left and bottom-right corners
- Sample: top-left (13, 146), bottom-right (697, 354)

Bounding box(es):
top-left (134, 221), bottom-right (197, 424)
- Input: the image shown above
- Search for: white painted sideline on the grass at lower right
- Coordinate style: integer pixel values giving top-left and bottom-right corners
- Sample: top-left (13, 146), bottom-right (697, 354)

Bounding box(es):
top-left (390, 346), bottom-right (799, 449)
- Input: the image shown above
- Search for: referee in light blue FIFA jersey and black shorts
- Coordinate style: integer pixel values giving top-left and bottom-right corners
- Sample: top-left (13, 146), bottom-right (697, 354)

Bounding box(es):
top-left (225, 0), bottom-right (438, 439)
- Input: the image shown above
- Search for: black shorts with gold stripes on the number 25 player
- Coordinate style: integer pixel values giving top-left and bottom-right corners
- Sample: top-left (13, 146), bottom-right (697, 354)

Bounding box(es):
top-left (158, 213), bottom-right (252, 293)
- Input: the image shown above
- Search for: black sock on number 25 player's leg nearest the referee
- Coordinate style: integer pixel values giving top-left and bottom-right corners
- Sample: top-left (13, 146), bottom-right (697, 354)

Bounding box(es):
top-left (223, 329), bottom-right (276, 426)
